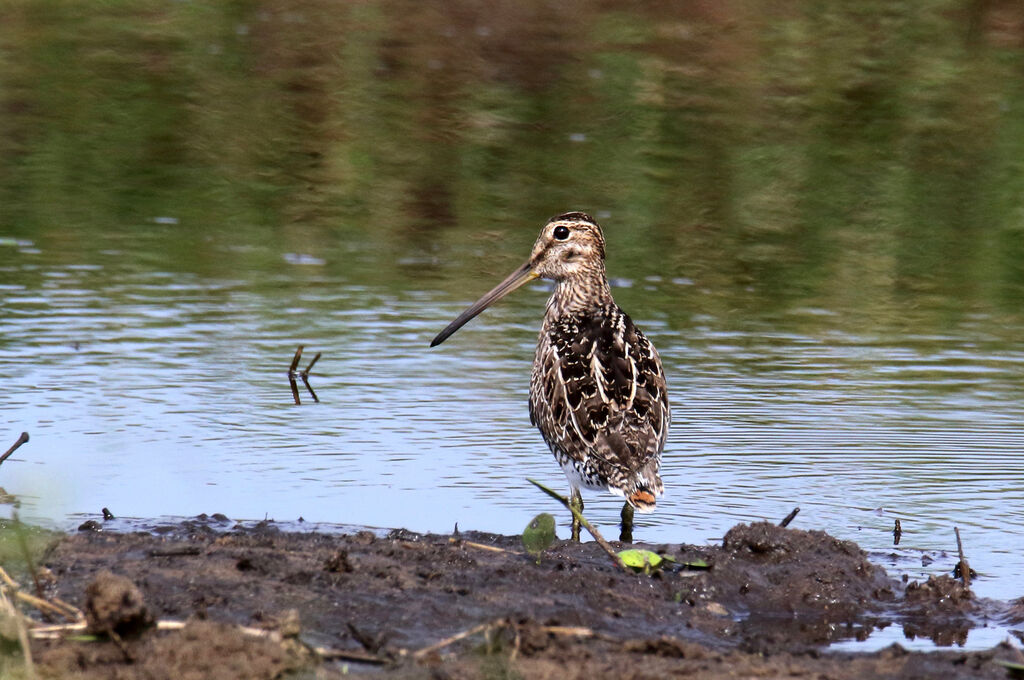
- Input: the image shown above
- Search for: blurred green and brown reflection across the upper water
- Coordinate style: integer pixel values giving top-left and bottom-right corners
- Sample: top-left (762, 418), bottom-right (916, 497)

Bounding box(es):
top-left (0, 0), bottom-right (1024, 331)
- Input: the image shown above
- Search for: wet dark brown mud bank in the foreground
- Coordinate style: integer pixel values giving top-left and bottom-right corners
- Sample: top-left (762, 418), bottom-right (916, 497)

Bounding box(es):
top-left (9, 517), bottom-right (1021, 679)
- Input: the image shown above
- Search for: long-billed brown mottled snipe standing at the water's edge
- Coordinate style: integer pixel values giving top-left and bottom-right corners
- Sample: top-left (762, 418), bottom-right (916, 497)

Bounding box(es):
top-left (430, 212), bottom-right (672, 542)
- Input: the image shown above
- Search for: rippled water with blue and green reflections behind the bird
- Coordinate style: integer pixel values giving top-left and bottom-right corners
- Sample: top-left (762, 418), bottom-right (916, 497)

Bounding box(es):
top-left (0, 2), bottom-right (1024, 644)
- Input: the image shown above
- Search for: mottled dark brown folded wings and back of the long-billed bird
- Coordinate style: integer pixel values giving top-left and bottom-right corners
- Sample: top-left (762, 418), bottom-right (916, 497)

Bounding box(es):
top-left (530, 307), bottom-right (671, 485)
